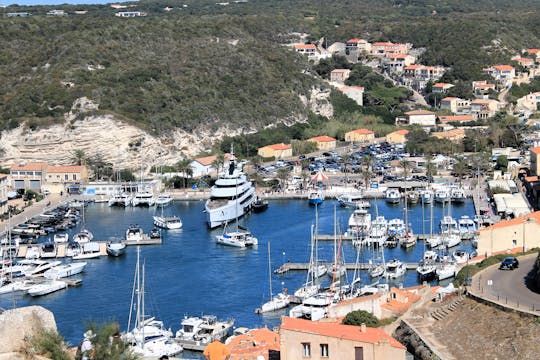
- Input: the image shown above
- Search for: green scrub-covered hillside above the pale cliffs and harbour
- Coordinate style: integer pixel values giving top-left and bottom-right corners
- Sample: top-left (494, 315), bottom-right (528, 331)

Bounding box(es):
top-left (0, 0), bottom-right (540, 137)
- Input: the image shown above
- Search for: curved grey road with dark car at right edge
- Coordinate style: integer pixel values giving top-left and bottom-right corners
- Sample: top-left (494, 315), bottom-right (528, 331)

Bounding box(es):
top-left (472, 254), bottom-right (540, 311)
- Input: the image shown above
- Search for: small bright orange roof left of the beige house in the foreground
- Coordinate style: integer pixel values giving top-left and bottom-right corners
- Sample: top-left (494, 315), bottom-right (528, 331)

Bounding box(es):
top-left (227, 328), bottom-right (280, 360)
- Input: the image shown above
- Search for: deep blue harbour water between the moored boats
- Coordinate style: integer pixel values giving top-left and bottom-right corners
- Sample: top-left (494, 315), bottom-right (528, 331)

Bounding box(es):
top-left (0, 200), bottom-right (474, 356)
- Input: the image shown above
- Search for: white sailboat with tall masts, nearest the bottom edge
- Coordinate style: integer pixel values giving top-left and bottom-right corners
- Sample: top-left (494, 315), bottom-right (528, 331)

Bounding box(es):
top-left (123, 247), bottom-right (183, 357)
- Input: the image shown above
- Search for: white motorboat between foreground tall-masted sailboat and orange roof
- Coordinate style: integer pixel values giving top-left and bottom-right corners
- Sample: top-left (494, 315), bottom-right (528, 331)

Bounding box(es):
top-left (174, 315), bottom-right (234, 351)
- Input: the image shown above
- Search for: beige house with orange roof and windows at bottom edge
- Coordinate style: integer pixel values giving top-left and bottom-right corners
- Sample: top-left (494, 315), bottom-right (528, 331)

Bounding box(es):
top-left (279, 316), bottom-right (406, 360)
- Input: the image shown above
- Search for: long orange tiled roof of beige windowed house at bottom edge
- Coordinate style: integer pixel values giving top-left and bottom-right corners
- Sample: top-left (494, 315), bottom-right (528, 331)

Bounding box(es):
top-left (281, 316), bottom-right (405, 349)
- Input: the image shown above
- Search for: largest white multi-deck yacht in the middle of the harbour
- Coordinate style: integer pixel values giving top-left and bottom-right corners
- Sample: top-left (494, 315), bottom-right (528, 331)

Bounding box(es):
top-left (205, 151), bottom-right (257, 228)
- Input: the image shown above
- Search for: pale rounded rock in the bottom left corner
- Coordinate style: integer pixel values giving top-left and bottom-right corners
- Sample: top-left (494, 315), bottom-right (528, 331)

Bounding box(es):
top-left (0, 306), bottom-right (56, 359)
